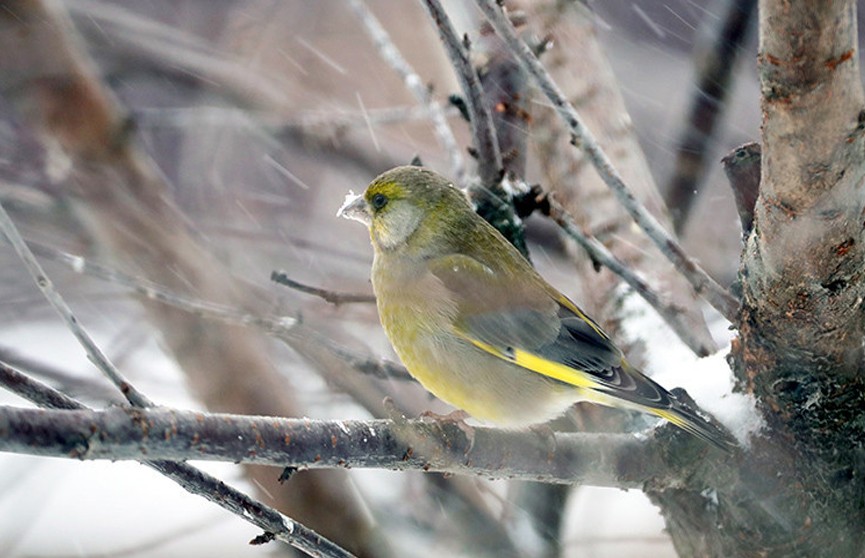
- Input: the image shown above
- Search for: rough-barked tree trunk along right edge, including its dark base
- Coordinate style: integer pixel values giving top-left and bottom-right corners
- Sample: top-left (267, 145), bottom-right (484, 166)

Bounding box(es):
top-left (647, 0), bottom-right (865, 556)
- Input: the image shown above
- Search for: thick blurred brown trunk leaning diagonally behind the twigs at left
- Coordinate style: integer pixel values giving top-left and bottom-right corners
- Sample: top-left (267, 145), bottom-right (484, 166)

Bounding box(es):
top-left (0, 0), bottom-right (387, 554)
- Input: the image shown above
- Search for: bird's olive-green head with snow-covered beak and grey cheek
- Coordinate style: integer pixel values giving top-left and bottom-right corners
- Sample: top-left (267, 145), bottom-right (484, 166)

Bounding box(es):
top-left (337, 166), bottom-right (474, 254)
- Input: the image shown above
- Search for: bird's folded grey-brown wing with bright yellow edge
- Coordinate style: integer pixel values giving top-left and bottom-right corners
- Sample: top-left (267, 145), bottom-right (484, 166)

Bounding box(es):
top-left (430, 254), bottom-right (670, 408)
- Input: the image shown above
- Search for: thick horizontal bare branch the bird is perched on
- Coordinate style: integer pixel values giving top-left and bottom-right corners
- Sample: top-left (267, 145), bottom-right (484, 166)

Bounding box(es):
top-left (0, 407), bottom-right (676, 488)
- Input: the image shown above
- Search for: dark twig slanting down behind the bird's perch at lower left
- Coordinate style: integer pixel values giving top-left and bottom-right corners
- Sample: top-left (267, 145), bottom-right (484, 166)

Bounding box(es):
top-left (0, 362), bottom-right (353, 558)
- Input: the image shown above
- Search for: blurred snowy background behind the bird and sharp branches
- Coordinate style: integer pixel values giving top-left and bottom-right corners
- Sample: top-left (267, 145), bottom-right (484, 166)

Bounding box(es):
top-left (0, 0), bottom-right (760, 557)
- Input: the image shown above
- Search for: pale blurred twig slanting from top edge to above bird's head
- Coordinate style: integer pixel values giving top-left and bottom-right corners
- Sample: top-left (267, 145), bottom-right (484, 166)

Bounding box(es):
top-left (347, 0), bottom-right (467, 188)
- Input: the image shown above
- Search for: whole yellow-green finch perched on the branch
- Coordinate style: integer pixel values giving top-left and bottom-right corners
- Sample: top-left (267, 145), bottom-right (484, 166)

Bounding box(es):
top-left (338, 166), bottom-right (735, 456)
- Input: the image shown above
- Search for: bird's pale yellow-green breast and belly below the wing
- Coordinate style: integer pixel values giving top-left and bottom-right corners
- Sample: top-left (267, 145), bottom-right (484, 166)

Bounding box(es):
top-left (372, 255), bottom-right (581, 427)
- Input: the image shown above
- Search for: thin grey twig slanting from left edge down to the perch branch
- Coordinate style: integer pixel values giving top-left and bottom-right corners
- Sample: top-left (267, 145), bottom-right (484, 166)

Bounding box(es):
top-left (0, 203), bottom-right (153, 407)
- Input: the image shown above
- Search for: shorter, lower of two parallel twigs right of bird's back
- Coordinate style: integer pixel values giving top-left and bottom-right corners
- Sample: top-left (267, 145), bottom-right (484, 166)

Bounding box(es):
top-left (547, 198), bottom-right (714, 357)
